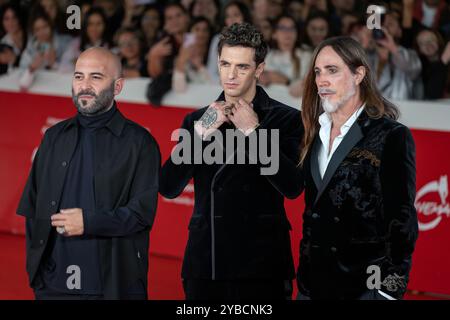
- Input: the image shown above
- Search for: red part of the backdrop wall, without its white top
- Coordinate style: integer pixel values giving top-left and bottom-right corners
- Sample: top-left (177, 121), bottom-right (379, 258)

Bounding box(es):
top-left (0, 92), bottom-right (450, 294)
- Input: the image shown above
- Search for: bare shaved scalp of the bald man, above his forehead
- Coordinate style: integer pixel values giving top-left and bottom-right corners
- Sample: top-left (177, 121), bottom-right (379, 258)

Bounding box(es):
top-left (75, 47), bottom-right (122, 79)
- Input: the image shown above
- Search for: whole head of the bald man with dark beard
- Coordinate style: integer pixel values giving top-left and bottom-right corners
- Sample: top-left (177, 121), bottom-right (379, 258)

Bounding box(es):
top-left (72, 47), bottom-right (124, 115)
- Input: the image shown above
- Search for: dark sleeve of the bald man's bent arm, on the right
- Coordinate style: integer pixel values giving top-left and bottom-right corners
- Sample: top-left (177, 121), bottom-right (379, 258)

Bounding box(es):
top-left (83, 134), bottom-right (161, 237)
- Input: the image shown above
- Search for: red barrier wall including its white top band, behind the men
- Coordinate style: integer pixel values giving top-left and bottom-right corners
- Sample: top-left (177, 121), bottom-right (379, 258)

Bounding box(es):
top-left (0, 72), bottom-right (450, 294)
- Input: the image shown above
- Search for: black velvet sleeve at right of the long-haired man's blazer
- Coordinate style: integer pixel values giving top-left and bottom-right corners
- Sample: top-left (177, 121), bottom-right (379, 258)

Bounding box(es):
top-left (380, 126), bottom-right (418, 298)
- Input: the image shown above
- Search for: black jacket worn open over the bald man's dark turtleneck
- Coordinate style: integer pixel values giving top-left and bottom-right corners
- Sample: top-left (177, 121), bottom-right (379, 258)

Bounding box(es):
top-left (17, 106), bottom-right (160, 299)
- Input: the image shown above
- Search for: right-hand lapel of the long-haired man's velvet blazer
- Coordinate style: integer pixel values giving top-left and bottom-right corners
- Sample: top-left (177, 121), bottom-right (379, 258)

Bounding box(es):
top-left (313, 121), bottom-right (364, 204)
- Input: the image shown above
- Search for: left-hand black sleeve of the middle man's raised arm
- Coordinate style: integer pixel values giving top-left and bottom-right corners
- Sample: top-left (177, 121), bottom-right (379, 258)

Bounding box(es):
top-left (159, 114), bottom-right (197, 199)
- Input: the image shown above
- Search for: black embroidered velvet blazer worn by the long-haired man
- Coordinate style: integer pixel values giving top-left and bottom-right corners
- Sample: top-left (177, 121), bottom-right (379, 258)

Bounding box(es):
top-left (297, 111), bottom-right (418, 299)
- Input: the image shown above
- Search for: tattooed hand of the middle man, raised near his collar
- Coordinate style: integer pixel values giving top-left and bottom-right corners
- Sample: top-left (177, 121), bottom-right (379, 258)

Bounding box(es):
top-left (194, 101), bottom-right (232, 138)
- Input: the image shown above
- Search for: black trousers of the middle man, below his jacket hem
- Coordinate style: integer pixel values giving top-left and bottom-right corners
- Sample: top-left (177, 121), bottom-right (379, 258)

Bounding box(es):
top-left (183, 279), bottom-right (292, 300)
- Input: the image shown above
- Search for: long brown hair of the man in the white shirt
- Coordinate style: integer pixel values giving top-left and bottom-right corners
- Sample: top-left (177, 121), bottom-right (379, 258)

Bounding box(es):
top-left (299, 37), bottom-right (399, 165)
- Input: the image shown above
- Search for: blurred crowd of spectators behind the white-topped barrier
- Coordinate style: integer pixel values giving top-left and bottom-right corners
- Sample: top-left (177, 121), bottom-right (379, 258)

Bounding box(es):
top-left (0, 0), bottom-right (450, 102)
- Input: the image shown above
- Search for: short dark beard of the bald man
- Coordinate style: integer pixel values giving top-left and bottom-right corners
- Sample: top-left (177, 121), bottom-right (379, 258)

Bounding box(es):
top-left (72, 81), bottom-right (114, 116)
